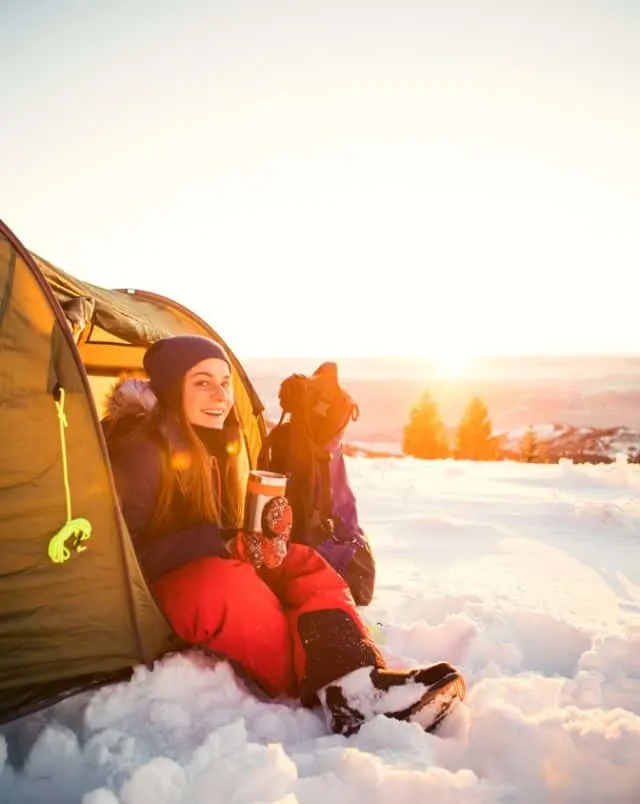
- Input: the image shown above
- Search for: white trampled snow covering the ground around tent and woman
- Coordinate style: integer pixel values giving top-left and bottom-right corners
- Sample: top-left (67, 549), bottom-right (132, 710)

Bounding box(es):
top-left (0, 458), bottom-right (640, 804)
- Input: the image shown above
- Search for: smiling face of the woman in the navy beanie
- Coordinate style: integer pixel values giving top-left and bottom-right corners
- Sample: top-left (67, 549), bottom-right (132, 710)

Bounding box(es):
top-left (182, 357), bottom-right (233, 430)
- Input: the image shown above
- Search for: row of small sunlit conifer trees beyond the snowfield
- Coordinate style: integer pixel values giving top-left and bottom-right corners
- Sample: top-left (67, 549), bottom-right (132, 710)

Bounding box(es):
top-left (402, 391), bottom-right (546, 463)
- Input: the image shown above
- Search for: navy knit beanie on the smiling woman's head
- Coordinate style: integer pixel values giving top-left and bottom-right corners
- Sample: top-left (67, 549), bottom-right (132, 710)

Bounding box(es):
top-left (142, 335), bottom-right (231, 399)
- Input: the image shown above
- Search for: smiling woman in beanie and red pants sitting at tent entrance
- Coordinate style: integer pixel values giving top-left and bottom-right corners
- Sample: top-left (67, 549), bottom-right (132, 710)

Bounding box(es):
top-left (104, 336), bottom-right (465, 734)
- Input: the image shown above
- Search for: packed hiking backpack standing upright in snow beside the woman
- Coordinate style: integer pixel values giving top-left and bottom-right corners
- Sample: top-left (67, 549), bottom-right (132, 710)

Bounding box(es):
top-left (260, 363), bottom-right (375, 606)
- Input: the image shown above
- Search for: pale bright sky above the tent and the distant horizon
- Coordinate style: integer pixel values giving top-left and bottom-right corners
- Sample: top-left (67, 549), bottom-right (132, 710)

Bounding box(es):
top-left (0, 0), bottom-right (640, 367)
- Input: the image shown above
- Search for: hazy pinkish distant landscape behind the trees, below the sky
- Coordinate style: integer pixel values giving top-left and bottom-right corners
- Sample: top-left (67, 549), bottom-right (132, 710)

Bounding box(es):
top-left (242, 355), bottom-right (640, 440)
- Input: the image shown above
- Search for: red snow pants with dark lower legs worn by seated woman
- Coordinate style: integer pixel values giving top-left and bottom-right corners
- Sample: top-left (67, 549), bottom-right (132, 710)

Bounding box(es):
top-left (153, 544), bottom-right (384, 697)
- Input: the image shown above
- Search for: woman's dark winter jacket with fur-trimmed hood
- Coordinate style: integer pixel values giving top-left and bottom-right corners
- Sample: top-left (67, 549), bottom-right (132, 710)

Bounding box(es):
top-left (102, 379), bottom-right (235, 582)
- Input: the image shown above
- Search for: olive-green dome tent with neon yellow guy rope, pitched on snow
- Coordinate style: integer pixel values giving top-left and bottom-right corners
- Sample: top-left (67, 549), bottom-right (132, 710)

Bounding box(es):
top-left (0, 221), bottom-right (265, 722)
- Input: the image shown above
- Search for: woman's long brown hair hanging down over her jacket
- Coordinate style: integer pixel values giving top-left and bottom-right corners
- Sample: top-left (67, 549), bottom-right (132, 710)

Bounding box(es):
top-left (149, 378), bottom-right (249, 533)
